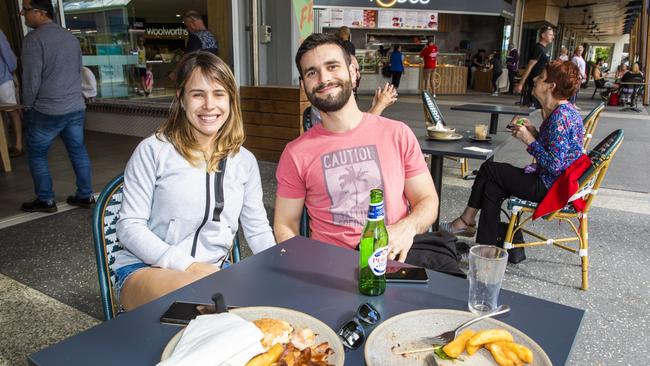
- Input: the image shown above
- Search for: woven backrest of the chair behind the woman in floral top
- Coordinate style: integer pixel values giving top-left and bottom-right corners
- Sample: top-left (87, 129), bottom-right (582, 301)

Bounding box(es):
top-left (569, 129), bottom-right (624, 212)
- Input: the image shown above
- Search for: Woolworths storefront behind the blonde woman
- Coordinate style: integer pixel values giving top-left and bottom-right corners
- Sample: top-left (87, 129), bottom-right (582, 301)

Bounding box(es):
top-left (60, 0), bottom-right (207, 99)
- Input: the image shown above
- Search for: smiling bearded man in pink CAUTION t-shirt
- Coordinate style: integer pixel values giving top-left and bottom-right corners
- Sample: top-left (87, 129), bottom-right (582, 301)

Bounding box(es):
top-left (274, 33), bottom-right (438, 262)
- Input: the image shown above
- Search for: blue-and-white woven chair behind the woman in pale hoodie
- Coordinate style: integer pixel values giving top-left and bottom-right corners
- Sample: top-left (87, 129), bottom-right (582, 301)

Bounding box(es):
top-left (92, 174), bottom-right (240, 320)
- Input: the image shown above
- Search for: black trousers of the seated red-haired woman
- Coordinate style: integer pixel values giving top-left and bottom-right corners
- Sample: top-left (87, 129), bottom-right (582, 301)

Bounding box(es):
top-left (467, 161), bottom-right (548, 245)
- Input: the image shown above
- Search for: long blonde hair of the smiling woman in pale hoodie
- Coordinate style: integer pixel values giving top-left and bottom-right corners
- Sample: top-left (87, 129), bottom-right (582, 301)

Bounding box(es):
top-left (156, 51), bottom-right (245, 172)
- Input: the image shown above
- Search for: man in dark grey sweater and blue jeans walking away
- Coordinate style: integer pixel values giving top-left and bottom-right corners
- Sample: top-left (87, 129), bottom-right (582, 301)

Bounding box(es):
top-left (20, 0), bottom-right (95, 212)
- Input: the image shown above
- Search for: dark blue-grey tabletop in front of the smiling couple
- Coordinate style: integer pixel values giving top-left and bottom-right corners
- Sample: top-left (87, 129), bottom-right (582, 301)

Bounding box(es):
top-left (29, 237), bottom-right (584, 366)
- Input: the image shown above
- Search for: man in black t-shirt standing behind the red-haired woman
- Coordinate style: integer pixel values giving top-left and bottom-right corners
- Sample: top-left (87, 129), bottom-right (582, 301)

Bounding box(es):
top-left (514, 26), bottom-right (555, 109)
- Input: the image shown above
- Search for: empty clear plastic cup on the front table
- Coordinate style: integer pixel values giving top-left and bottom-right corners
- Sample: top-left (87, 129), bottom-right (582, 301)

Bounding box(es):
top-left (467, 245), bottom-right (508, 315)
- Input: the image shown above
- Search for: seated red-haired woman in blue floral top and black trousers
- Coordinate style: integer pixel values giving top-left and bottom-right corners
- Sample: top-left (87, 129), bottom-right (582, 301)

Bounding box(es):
top-left (441, 61), bottom-right (584, 245)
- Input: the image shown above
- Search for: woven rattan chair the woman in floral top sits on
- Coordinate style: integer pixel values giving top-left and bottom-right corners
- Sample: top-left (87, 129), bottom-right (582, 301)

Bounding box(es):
top-left (503, 130), bottom-right (623, 290)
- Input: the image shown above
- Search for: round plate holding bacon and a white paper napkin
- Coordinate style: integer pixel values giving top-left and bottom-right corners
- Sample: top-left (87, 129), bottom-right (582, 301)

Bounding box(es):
top-left (160, 306), bottom-right (345, 366)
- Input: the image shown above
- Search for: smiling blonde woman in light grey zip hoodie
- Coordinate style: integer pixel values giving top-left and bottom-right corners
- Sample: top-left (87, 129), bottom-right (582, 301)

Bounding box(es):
top-left (113, 51), bottom-right (275, 310)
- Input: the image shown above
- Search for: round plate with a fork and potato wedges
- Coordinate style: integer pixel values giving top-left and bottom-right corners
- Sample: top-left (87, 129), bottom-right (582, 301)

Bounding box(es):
top-left (364, 309), bottom-right (552, 366)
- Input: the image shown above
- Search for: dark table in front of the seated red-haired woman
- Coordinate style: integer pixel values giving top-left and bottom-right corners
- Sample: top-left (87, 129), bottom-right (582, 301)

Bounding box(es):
top-left (413, 128), bottom-right (511, 231)
